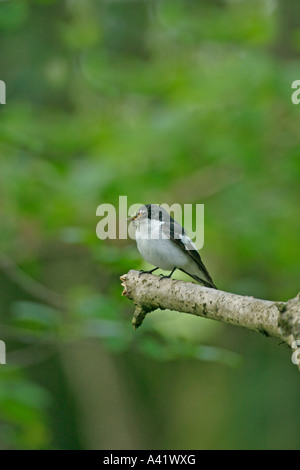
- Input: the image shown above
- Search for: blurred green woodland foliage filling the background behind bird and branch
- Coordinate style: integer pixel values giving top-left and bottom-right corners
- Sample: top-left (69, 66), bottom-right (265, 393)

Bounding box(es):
top-left (0, 0), bottom-right (300, 449)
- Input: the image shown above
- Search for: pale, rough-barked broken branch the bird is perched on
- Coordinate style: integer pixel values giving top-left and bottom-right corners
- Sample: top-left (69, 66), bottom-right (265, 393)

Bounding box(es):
top-left (121, 270), bottom-right (300, 368)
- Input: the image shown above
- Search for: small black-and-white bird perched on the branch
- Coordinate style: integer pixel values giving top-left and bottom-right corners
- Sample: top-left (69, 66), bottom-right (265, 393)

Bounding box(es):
top-left (128, 204), bottom-right (217, 289)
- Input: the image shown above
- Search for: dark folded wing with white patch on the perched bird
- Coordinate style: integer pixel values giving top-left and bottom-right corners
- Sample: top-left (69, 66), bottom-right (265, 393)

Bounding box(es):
top-left (162, 216), bottom-right (215, 287)
